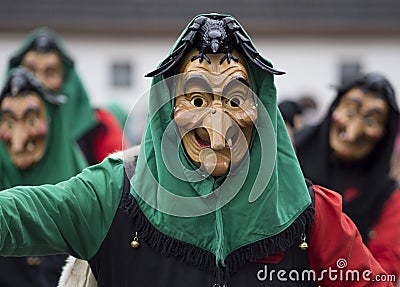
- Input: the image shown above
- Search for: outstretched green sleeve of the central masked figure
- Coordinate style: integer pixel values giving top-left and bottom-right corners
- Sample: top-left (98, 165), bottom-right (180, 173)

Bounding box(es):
top-left (0, 158), bottom-right (124, 259)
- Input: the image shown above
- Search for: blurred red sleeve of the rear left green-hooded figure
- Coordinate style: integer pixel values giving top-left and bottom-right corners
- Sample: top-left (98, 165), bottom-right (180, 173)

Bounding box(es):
top-left (92, 109), bottom-right (128, 162)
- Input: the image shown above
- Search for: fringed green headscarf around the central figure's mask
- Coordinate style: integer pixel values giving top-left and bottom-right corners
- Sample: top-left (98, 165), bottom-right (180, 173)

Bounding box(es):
top-left (126, 14), bottom-right (311, 266)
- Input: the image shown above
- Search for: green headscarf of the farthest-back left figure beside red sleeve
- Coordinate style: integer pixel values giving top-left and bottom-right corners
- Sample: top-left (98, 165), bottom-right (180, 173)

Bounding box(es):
top-left (7, 27), bottom-right (97, 140)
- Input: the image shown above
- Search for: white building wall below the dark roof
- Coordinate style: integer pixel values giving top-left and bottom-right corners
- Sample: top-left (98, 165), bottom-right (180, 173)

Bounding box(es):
top-left (0, 34), bottom-right (400, 126)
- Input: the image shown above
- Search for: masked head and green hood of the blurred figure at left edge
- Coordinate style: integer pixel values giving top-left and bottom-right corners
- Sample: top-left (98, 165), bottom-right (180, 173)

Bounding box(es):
top-left (0, 67), bottom-right (87, 190)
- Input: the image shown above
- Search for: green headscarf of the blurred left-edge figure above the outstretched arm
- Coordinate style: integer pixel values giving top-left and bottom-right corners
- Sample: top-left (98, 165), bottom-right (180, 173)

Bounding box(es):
top-left (0, 68), bottom-right (87, 190)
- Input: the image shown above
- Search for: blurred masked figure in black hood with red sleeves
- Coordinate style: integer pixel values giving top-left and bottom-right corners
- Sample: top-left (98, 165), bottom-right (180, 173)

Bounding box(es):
top-left (295, 73), bottom-right (400, 275)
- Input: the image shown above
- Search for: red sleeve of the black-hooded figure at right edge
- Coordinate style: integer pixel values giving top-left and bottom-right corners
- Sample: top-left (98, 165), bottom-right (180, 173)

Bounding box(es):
top-left (368, 190), bottom-right (400, 276)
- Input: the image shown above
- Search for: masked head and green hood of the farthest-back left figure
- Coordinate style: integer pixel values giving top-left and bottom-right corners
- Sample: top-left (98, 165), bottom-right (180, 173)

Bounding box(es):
top-left (7, 27), bottom-right (97, 140)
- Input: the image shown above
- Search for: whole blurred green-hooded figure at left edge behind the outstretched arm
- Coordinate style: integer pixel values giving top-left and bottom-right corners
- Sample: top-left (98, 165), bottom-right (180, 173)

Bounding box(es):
top-left (0, 68), bottom-right (86, 287)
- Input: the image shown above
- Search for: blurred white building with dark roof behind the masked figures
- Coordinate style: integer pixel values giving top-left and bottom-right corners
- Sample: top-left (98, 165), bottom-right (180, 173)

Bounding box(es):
top-left (0, 0), bottom-right (400, 129)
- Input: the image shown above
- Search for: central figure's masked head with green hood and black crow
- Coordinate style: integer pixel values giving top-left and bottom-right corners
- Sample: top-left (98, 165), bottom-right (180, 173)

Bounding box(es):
top-left (126, 11), bottom-right (312, 272)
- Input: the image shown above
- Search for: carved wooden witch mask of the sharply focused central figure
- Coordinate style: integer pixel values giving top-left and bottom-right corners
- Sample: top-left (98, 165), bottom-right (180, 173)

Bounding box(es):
top-left (174, 50), bottom-right (257, 176)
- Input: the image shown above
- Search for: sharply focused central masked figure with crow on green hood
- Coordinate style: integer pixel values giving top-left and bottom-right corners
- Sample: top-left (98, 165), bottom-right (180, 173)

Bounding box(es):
top-left (0, 14), bottom-right (393, 287)
